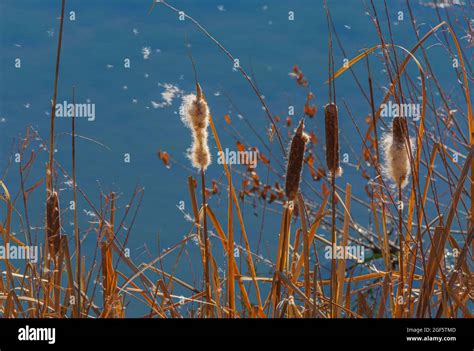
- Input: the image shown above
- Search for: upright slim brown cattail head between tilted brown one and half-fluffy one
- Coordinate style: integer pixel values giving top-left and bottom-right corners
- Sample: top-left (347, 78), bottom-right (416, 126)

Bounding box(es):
top-left (324, 103), bottom-right (342, 177)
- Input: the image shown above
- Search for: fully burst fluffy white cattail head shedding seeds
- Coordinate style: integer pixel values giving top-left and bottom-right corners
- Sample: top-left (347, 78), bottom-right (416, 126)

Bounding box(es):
top-left (182, 83), bottom-right (211, 170)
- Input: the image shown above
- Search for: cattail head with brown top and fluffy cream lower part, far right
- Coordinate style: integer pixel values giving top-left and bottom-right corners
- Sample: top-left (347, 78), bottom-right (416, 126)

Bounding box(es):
top-left (382, 117), bottom-right (413, 188)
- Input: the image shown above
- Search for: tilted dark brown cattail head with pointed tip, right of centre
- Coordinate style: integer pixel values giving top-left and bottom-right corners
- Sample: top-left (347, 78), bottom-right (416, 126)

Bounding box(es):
top-left (285, 118), bottom-right (309, 201)
